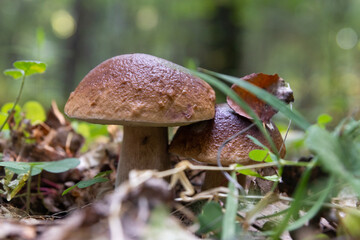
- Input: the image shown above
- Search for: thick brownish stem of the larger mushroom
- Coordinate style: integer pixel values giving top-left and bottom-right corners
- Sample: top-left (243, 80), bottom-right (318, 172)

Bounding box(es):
top-left (115, 126), bottom-right (170, 187)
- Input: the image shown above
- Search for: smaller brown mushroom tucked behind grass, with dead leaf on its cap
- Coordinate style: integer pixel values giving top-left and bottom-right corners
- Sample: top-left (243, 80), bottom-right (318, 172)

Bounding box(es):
top-left (169, 104), bottom-right (286, 190)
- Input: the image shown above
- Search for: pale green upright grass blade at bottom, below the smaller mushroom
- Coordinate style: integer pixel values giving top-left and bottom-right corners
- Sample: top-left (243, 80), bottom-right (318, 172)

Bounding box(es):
top-left (221, 172), bottom-right (239, 240)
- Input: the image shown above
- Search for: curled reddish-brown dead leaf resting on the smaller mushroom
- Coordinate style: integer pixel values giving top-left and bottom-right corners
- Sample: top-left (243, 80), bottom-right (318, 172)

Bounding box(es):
top-left (227, 73), bottom-right (294, 123)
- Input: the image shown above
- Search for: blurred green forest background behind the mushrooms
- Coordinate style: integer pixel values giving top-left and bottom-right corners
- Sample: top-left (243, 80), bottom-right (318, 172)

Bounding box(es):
top-left (0, 0), bottom-right (360, 122)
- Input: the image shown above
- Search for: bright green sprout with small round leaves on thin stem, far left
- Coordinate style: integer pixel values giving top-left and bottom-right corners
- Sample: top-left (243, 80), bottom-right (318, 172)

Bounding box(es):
top-left (0, 60), bottom-right (46, 132)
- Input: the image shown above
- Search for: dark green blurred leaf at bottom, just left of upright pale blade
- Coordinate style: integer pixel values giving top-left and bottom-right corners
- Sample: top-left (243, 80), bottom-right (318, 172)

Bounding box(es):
top-left (197, 202), bottom-right (223, 234)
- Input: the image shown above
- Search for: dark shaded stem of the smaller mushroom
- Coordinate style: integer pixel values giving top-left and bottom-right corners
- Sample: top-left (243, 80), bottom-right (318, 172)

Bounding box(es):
top-left (201, 171), bottom-right (246, 191)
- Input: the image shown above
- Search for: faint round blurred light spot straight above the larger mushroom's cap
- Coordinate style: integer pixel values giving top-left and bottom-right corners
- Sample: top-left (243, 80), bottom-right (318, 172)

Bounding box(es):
top-left (136, 6), bottom-right (159, 31)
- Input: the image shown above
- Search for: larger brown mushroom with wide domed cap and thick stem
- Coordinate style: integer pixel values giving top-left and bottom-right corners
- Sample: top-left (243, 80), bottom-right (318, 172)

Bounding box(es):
top-left (65, 53), bottom-right (215, 186)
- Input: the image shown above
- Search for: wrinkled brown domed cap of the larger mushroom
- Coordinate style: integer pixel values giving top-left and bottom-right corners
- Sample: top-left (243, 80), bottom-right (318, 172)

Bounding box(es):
top-left (65, 54), bottom-right (215, 127)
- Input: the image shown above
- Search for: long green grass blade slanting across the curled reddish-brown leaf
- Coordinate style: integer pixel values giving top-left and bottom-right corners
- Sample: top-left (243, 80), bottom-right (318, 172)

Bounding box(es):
top-left (201, 69), bottom-right (310, 130)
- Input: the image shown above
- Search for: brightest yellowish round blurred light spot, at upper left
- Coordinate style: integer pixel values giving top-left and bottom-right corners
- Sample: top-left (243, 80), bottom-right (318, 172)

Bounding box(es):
top-left (51, 10), bottom-right (76, 39)
